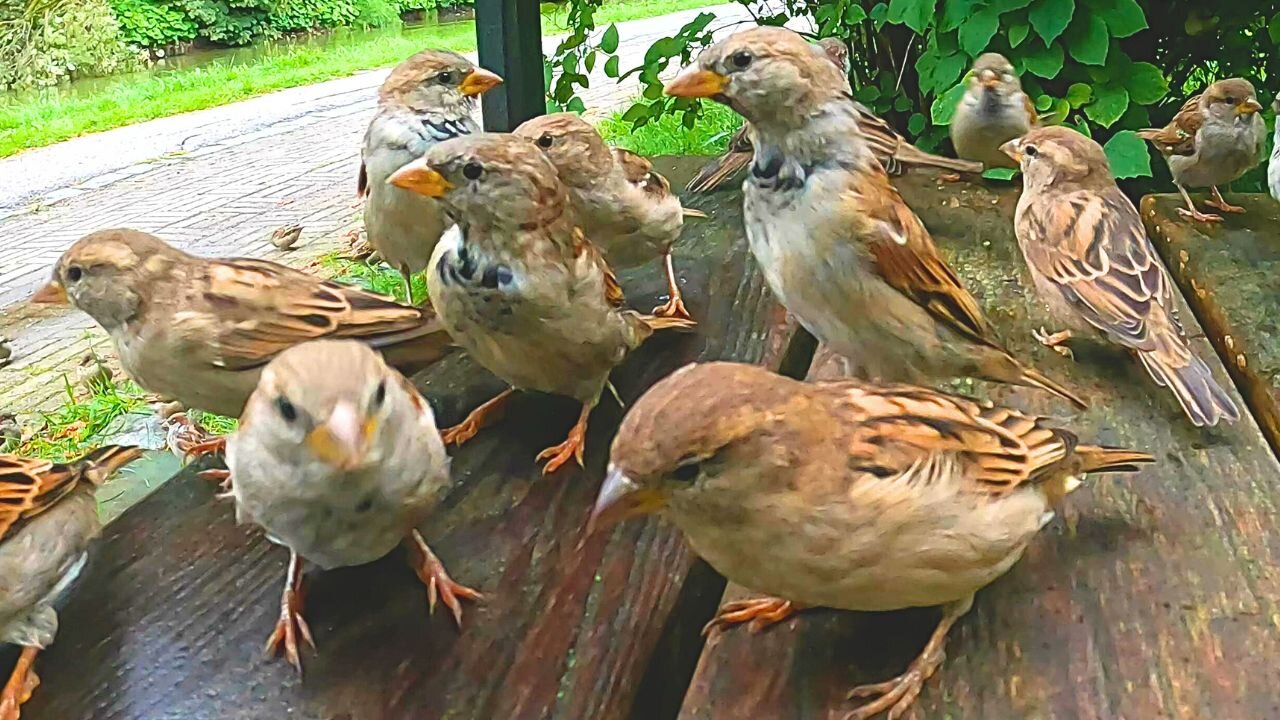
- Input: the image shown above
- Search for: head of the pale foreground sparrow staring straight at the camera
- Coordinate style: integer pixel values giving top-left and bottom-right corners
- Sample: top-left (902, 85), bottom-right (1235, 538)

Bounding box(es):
top-left (237, 340), bottom-right (419, 471)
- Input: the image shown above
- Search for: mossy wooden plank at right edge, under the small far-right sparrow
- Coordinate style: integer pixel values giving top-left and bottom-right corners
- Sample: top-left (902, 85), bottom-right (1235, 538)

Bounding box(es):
top-left (1142, 195), bottom-right (1280, 452)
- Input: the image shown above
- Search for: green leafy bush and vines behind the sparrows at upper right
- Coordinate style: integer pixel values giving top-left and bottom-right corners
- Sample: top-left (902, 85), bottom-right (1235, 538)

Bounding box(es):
top-left (547, 0), bottom-right (1280, 191)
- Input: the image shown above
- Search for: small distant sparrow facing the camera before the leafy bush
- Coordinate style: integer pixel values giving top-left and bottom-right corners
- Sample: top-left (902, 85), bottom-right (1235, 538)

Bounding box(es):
top-left (951, 53), bottom-right (1039, 168)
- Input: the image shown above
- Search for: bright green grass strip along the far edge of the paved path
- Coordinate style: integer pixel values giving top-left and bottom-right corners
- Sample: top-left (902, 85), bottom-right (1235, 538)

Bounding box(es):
top-left (0, 0), bottom-right (717, 158)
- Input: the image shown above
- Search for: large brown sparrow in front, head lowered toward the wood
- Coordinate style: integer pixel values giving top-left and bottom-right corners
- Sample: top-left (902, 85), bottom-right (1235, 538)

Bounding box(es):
top-left (590, 363), bottom-right (1152, 720)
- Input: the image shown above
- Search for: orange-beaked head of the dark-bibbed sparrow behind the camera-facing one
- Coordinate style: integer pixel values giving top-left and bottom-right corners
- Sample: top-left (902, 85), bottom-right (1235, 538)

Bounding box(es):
top-left (387, 132), bottom-right (566, 227)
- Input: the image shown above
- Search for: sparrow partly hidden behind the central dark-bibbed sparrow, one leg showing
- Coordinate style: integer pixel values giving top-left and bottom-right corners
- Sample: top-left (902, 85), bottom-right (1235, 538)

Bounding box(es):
top-left (515, 113), bottom-right (701, 319)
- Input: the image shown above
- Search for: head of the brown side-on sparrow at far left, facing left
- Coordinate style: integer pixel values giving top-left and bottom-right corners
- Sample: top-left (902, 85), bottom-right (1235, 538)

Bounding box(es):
top-left (32, 228), bottom-right (186, 331)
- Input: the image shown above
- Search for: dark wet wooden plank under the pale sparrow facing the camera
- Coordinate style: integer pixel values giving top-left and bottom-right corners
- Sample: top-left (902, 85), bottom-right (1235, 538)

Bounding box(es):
top-left (24, 160), bottom-right (787, 720)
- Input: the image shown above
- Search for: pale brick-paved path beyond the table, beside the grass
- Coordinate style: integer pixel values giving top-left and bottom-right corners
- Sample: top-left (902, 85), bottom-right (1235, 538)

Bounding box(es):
top-left (0, 4), bottom-right (788, 414)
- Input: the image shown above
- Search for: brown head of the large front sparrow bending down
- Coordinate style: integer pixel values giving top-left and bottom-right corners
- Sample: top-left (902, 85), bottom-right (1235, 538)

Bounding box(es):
top-left (591, 363), bottom-right (805, 528)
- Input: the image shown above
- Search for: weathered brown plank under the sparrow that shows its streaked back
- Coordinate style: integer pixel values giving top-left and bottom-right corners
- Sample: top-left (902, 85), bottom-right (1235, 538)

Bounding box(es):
top-left (680, 176), bottom-right (1280, 720)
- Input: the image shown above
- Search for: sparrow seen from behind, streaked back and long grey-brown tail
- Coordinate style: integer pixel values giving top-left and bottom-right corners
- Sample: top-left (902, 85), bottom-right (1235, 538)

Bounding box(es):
top-left (1004, 127), bottom-right (1240, 427)
